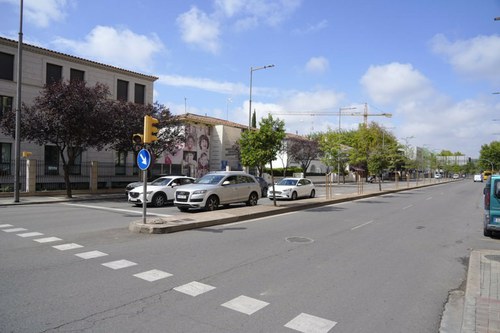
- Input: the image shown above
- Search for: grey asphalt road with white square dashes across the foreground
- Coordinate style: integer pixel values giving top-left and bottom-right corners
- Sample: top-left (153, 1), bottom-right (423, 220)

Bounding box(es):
top-left (0, 181), bottom-right (500, 333)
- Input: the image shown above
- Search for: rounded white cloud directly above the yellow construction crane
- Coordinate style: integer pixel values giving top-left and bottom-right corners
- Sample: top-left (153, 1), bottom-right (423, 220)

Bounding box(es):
top-left (361, 63), bottom-right (432, 104)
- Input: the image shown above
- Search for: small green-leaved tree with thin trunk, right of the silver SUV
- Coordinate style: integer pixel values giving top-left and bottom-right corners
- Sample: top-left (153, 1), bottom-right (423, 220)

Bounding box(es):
top-left (239, 115), bottom-right (285, 205)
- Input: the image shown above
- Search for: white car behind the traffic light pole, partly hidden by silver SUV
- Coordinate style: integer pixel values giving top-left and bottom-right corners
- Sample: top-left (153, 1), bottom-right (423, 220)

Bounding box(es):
top-left (128, 176), bottom-right (195, 207)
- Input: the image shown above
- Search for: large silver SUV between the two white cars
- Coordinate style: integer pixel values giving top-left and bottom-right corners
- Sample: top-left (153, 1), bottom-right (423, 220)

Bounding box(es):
top-left (174, 171), bottom-right (261, 212)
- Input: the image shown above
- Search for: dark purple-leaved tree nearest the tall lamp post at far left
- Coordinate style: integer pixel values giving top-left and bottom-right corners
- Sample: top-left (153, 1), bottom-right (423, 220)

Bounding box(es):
top-left (2, 80), bottom-right (115, 198)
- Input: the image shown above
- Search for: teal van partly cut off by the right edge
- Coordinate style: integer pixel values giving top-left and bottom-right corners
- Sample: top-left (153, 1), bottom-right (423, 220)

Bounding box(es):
top-left (483, 175), bottom-right (500, 237)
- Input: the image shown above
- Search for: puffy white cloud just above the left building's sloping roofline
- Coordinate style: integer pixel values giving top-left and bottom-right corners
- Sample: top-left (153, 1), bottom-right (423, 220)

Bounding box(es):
top-left (53, 26), bottom-right (163, 71)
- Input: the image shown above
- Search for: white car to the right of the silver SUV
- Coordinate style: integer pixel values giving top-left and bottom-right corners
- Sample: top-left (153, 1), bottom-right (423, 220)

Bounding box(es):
top-left (267, 178), bottom-right (316, 200)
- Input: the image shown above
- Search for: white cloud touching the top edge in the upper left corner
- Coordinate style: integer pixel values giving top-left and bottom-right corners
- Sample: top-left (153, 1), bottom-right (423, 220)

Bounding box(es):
top-left (0, 0), bottom-right (72, 28)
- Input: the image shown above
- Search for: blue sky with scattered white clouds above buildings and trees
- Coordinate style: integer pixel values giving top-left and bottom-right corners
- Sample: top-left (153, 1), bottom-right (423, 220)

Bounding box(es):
top-left (0, 0), bottom-right (500, 158)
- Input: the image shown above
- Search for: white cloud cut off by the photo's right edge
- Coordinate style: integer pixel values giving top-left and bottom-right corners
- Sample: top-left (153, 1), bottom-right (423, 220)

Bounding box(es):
top-left (431, 34), bottom-right (500, 82)
